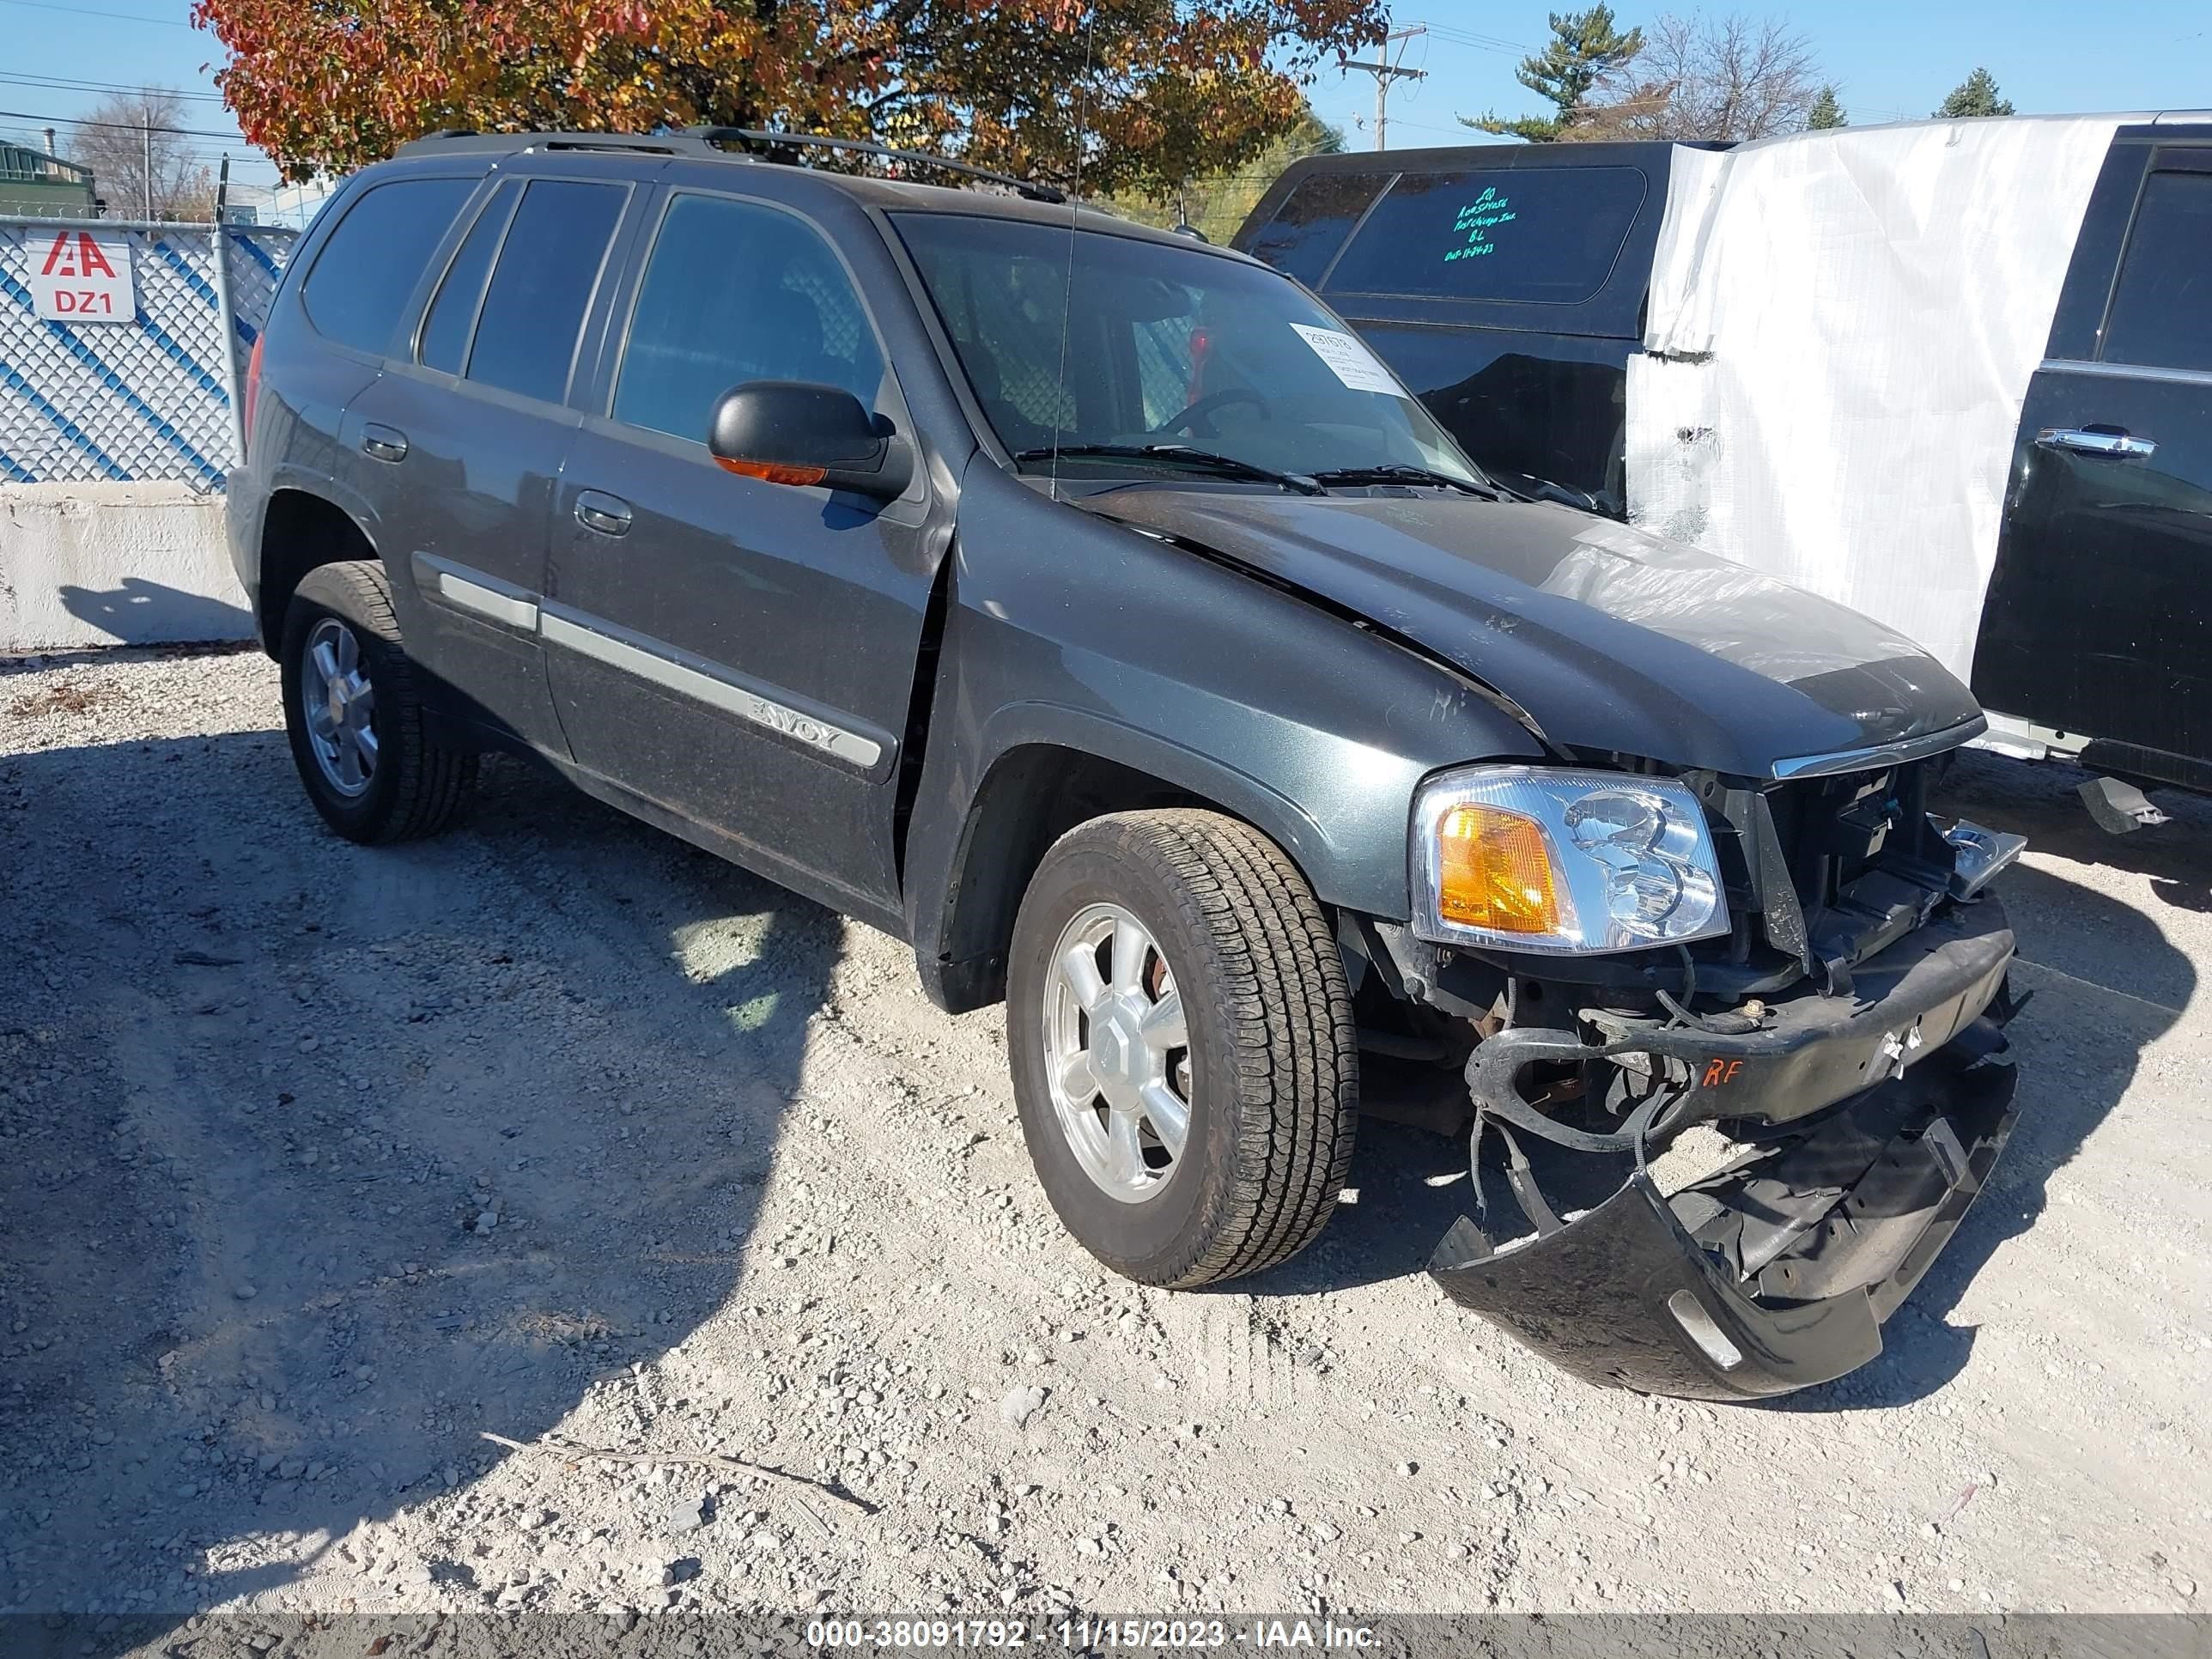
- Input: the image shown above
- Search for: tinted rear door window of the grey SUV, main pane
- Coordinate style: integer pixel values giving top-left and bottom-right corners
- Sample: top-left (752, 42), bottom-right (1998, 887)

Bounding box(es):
top-left (469, 179), bottom-right (630, 403)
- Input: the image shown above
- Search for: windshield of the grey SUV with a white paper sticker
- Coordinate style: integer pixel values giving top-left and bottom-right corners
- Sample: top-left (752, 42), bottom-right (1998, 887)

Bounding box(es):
top-left (894, 212), bottom-right (1482, 483)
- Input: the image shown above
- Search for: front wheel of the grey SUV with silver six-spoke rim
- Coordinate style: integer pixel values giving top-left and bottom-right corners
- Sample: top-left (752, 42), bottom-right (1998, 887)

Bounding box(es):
top-left (1006, 810), bottom-right (1358, 1290)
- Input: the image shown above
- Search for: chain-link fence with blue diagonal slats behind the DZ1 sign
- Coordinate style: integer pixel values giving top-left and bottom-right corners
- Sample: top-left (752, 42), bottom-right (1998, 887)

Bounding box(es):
top-left (0, 219), bottom-right (299, 489)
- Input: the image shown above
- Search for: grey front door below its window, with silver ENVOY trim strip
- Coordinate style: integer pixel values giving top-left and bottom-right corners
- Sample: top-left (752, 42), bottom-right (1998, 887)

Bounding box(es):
top-left (542, 422), bottom-right (929, 902)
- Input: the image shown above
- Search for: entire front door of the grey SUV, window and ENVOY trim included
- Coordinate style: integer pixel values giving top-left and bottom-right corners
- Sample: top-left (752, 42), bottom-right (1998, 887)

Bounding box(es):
top-left (542, 191), bottom-right (942, 909)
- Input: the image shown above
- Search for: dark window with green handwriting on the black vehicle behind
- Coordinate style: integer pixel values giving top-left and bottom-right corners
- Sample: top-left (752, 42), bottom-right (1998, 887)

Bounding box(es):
top-left (1329, 166), bottom-right (1644, 305)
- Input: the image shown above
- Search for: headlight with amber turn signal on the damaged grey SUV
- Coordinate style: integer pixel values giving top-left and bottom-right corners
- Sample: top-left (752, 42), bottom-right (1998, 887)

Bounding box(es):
top-left (1411, 765), bottom-right (1728, 956)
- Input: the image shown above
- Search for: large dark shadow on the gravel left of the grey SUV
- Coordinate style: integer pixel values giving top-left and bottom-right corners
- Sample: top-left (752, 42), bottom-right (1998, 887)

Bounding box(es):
top-left (0, 732), bottom-right (842, 1652)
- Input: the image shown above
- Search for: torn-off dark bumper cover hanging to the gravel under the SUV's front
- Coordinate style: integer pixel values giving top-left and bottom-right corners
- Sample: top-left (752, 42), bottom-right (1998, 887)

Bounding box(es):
top-left (1429, 986), bottom-right (2017, 1401)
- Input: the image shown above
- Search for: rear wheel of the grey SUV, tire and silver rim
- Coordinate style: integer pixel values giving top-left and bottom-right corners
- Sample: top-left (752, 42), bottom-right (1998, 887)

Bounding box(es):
top-left (276, 560), bottom-right (477, 845)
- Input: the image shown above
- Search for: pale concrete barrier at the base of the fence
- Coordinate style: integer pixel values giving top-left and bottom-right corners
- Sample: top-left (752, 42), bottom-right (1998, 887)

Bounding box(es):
top-left (0, 484), bottom-right (254, 654)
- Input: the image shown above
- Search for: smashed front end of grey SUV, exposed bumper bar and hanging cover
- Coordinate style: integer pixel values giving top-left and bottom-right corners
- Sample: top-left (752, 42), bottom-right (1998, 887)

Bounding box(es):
top-left (1376, 761), bottom-right (2021, 1398)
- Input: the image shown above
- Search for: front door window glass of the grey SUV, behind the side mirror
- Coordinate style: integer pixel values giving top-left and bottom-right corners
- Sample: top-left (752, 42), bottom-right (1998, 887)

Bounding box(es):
top-left (615, 195), bottom-right (883, 442)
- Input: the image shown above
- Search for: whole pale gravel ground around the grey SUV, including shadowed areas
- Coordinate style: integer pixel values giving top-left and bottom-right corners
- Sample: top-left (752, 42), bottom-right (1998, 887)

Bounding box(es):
top-left (0, 653), bottom-right (2212, 1617)
